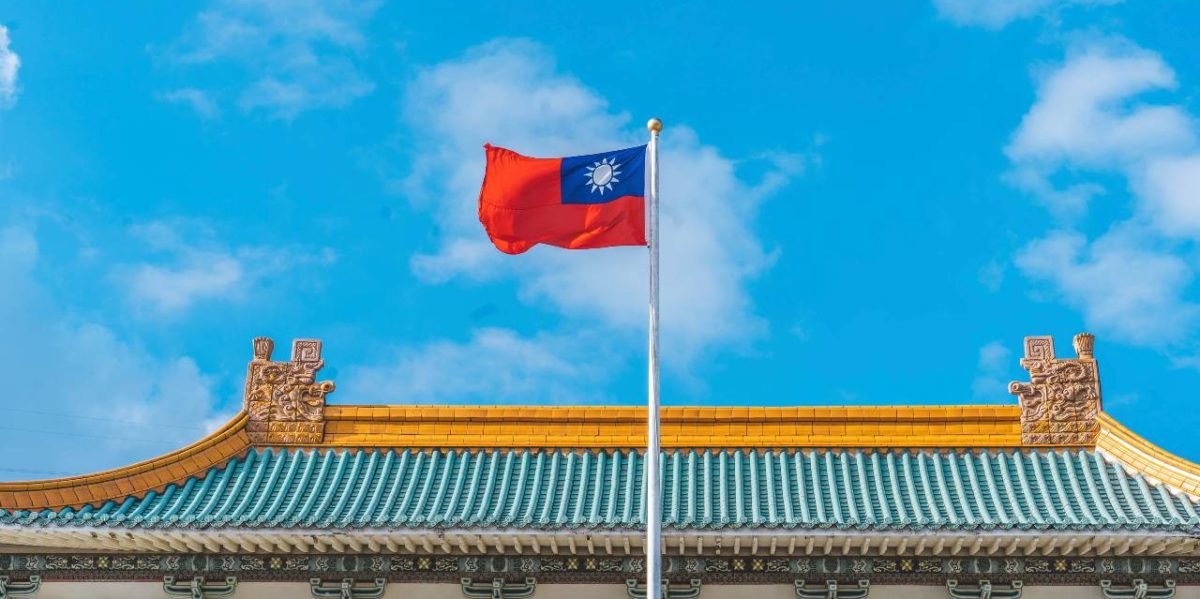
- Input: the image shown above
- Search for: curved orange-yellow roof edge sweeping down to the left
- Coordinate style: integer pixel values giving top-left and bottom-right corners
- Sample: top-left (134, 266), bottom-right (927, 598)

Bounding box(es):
top-left (0, 412), bottom-right (251, 510)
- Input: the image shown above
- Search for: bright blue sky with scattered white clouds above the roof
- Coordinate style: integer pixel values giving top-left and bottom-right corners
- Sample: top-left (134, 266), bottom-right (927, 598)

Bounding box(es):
top-left (0, 0), bottom-right (1200, 480)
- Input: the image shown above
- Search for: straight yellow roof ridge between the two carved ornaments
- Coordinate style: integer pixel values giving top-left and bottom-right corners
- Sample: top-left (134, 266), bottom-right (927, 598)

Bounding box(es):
top-left (316, 405), bottom-right (1021, 450)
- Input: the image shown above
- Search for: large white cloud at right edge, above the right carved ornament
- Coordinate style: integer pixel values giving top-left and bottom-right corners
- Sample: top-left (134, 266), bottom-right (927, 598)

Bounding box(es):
top-left (1007, 41), bottom-right (1200, 352)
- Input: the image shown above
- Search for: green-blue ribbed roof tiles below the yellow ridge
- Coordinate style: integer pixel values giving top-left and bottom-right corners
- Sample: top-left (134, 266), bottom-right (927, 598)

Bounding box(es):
top-left (9, 449), bottom-right (1200, 532)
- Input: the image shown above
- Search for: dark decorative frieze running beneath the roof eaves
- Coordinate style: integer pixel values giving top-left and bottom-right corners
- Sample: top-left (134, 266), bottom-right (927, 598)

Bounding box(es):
top-left (0, 553), bottom-right (1200, 585)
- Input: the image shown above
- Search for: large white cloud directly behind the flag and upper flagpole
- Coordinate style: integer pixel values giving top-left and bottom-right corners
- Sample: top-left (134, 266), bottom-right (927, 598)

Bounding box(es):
top-left (401, 41), bottom-right (803, 364)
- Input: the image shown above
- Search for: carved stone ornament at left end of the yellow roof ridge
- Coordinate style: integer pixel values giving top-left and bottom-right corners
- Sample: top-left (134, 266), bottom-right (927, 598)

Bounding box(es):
top-left (244, 337), bottom-right (334, 445)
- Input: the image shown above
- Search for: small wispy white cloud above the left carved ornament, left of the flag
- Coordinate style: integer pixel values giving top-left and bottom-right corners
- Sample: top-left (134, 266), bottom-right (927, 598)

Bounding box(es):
top-left (114, 221), bottom-right (335, 316)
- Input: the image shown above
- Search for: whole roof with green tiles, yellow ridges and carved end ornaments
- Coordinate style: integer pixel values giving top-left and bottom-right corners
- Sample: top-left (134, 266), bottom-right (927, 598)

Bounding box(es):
top-left (0, 335), bottom-right (1200, 551)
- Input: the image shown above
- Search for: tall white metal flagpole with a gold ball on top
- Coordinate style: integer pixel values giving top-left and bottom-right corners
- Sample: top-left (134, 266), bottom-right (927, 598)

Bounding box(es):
top-left (644, 119), bottom-right (662, 599)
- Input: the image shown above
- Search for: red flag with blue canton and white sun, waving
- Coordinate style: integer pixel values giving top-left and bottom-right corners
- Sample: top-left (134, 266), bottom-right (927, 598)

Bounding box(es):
top-left (479, 144), bottom-right (646, 253)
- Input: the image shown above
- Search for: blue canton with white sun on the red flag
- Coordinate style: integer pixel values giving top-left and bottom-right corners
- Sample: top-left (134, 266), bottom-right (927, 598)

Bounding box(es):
top-left (562, 145), bottom-right (646, 204)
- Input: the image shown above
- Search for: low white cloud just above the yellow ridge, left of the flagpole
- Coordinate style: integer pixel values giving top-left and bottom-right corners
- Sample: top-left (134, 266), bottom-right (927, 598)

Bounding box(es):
top-left (338, 329), bottom-right (619, 403)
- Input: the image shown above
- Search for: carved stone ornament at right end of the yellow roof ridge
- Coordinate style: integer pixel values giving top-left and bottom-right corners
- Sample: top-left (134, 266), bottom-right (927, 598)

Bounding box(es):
top-left (1008, 333), bottom-right (1100, 445)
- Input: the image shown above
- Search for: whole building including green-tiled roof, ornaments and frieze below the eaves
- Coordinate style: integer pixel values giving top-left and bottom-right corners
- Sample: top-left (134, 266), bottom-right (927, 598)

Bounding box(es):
top-left (0, 334), bottom-right (1200, 599)
